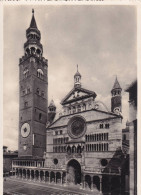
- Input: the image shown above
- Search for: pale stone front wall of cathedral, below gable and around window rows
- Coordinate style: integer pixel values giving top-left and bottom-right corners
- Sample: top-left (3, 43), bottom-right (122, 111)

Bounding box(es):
top-left (45, 112), bottom-right (122, 169)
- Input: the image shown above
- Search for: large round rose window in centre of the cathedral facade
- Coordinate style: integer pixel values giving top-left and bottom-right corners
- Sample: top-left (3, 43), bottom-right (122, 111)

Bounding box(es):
top-left (68, 116), bottom-right (86, 138)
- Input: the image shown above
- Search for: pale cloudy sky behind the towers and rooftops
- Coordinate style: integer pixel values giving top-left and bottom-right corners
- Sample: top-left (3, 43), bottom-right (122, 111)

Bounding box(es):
top-left (3, 5), bottom-right (137, 150)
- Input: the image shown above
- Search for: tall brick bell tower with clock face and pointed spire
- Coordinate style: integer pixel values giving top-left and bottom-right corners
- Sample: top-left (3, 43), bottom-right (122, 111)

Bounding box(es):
top-left (19, 10), bottom-right (48, 158)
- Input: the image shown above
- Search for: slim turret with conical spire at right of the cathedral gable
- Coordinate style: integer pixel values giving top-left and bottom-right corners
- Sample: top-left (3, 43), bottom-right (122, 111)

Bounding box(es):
top-left (111, 77), bottom-right (122, 114)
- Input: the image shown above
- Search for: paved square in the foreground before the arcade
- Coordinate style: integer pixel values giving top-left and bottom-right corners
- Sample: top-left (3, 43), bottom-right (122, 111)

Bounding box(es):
top-left (3, 177), bottom-right (100, 195)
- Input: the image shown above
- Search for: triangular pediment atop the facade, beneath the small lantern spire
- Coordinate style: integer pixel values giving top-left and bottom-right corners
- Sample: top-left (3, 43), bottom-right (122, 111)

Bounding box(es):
top-left (61, 88), bottom-right (96, 105)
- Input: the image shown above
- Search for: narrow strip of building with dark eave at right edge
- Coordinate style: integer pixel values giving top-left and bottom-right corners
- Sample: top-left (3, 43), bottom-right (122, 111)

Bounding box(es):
top-left (126, 80), bottom-right (137, 195)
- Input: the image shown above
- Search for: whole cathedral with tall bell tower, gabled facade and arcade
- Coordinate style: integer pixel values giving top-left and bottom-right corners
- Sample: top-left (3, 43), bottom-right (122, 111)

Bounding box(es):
top-left (12, 10), bottom-right (127, 193)
